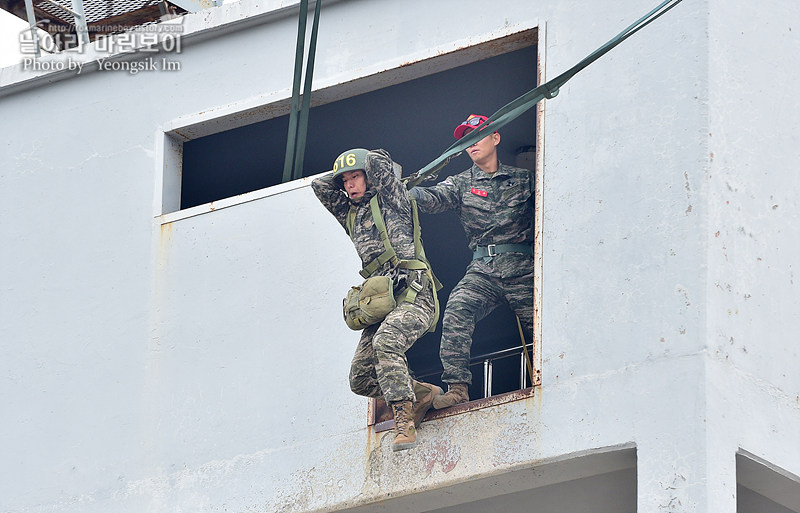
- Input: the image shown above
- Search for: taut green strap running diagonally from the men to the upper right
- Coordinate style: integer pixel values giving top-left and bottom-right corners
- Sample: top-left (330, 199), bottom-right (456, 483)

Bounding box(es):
top-left (403, 0), bottom-right (682, 189)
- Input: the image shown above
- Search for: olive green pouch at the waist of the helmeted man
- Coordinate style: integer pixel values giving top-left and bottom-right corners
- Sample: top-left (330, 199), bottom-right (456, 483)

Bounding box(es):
top-left (342, 276), bottom-right (397, 330)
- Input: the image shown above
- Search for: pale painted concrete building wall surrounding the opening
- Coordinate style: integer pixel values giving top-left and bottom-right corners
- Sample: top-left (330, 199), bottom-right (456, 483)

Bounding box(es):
top-left (0, 0), bottom-right (800, 513)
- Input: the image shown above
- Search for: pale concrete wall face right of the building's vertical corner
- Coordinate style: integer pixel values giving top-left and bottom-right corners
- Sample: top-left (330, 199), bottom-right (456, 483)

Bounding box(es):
top-left (704, 1), bottom-right (800, 511)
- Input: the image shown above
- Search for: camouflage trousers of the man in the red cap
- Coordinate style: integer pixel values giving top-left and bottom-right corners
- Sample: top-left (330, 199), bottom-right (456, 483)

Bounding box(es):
top-left (439, 259), bottom-right (533, 384)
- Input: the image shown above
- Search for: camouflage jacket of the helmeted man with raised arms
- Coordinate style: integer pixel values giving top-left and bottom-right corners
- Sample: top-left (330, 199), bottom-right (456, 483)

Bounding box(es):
top-left (311, 150), bottom-right (414, 276)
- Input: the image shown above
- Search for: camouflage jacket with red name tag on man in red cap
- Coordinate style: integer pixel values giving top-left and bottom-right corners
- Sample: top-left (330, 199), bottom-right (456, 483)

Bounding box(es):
top-left (413, 164), bottom-right (534, 251)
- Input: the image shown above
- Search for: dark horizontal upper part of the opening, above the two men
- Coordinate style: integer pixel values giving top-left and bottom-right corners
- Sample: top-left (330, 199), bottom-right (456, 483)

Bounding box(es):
top-left (176, 42), bottom-right (536, 210)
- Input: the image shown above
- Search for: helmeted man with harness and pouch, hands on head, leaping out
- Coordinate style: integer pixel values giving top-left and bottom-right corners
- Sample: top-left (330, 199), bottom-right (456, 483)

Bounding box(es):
top-left (311, 148), bottom-right (442, 451)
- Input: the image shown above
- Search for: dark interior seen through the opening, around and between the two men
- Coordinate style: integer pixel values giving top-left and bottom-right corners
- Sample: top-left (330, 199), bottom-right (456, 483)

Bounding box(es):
top-left (181, 46), bottom-right (537, 399)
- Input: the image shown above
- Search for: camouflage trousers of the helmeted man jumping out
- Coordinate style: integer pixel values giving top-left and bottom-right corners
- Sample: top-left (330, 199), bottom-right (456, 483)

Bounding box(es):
top-left (350, 286), bottom-right (434, 403)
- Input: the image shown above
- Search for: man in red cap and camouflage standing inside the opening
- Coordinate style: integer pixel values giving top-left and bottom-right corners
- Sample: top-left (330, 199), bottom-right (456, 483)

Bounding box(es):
top-left (411, 114), bottom-right (534, 408)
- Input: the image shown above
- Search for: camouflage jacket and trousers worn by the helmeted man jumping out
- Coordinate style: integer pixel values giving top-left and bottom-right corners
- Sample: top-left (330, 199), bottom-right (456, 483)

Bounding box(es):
top-left (311, 150), bottom-right (434, 402)
